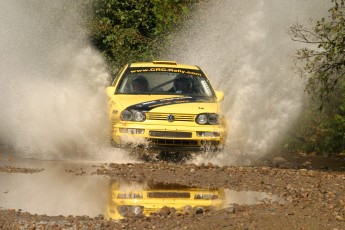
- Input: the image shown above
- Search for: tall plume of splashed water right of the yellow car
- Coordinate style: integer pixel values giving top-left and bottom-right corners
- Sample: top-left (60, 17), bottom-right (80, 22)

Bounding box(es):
top-left (164, 0), bottom-right (330, 164)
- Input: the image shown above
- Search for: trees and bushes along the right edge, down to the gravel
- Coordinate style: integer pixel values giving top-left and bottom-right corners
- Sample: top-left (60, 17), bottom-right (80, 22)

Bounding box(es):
top-left (287, 0), bottom-right (345, 155)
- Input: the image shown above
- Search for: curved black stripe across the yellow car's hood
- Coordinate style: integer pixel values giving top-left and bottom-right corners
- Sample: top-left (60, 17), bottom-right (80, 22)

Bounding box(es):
top-left (127, 97), bottom-right (199, 111)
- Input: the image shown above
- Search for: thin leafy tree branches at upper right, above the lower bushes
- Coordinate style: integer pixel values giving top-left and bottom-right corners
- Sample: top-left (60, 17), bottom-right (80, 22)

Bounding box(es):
top-left (291, 0), bottom-right (345, 104)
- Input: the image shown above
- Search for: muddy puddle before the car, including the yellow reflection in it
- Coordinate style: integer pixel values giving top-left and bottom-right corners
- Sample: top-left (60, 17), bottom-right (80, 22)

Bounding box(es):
top-left (0, 154), bottom-right (284, 219)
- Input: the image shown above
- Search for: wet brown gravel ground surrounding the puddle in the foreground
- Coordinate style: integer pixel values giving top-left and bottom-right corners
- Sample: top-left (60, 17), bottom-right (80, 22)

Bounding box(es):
top-left (0, 153), bottom-right (345, 230)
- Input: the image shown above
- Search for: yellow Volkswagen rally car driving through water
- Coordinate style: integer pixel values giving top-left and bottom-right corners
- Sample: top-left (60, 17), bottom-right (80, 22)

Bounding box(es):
top-left (106, 61), bottom-right (226, 151)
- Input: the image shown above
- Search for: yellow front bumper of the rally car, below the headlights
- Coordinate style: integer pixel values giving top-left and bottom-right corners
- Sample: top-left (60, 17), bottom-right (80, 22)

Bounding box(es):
top-left (112, 122), bottom-right (226, 151)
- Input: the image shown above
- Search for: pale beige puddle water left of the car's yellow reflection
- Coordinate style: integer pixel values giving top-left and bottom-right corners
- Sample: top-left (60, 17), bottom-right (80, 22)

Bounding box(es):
top-left (0, 155), bottom-right (109, 216)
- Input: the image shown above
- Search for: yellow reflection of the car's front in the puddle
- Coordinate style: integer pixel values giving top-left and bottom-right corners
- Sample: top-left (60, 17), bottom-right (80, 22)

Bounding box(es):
top-left (105, 181), bottom-right (225, 220)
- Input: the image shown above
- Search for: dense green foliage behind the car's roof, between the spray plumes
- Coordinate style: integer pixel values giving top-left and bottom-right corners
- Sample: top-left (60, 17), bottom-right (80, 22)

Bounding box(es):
top-left (83, 0), bottom-right (198, 72)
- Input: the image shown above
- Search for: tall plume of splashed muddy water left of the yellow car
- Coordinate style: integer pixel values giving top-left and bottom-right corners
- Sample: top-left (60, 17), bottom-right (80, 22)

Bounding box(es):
top-left (0, 0), bottom-right (134, 162)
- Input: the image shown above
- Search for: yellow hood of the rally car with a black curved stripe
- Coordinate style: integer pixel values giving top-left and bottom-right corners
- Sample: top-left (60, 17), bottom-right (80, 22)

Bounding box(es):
top-left (116, 95), bottom-right (219, 114)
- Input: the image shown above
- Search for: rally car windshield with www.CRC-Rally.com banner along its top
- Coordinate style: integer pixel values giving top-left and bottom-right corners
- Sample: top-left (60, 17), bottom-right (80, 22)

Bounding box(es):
top-left (116, 68), bottom-right (214, 98)
